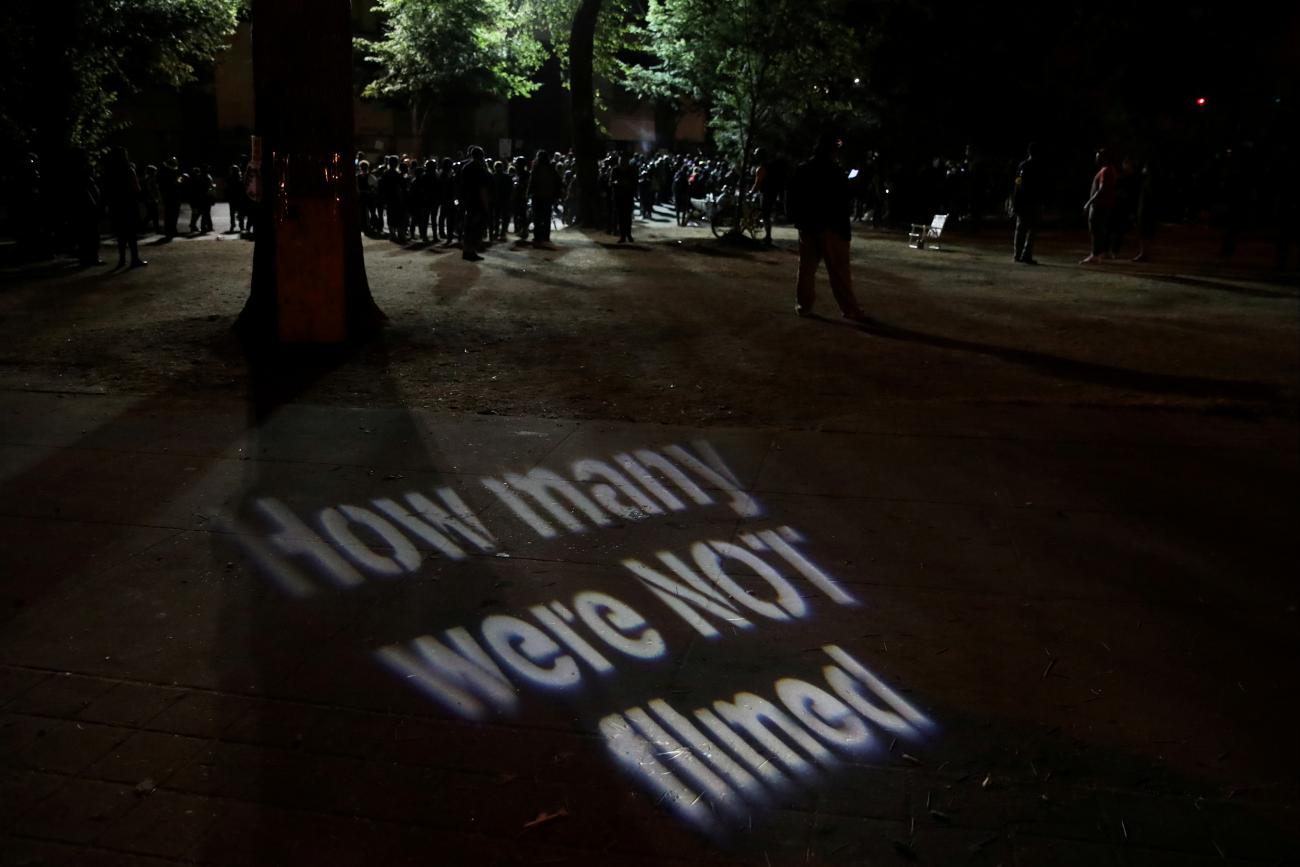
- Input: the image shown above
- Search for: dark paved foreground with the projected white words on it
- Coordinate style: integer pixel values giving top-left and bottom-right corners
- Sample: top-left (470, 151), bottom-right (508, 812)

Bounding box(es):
top-left (0, 391), bottom-right (1300, 866)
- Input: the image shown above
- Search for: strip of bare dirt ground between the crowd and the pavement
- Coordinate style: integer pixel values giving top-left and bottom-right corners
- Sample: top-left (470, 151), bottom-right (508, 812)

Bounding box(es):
top-left (0, 214), bottom-right (1300, 428)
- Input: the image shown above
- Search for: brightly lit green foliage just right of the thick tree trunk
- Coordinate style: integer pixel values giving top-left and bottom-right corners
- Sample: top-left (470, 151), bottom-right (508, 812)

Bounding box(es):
top-left (356, 0), bottom-right (546, 105)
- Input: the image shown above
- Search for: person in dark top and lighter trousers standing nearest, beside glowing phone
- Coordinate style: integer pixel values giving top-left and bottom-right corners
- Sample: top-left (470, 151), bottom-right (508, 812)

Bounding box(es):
top-left (790, 135), bottom-right (867, 322)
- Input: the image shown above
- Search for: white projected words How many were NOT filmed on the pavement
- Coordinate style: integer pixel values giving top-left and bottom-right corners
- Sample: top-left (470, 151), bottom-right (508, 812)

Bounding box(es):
top-left (226, 442), bottom-right (933, 831)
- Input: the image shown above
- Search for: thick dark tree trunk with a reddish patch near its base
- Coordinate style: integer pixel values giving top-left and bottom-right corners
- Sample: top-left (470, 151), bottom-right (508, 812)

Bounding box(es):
top-left (237, 0), bottom-right (386, 344)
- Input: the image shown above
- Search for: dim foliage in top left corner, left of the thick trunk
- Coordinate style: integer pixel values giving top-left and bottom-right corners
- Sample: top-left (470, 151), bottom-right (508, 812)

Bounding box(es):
top-left (0, 0), bottom-right (243, 152)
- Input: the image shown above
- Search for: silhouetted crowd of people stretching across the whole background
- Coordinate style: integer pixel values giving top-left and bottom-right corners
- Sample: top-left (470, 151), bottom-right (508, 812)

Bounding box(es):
top-left (7, 136), bottom-right (1297, 274)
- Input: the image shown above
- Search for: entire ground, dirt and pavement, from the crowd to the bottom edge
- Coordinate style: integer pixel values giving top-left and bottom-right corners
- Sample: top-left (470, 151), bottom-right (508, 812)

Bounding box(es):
top-left (0, 213), bottom-right (1300, 867)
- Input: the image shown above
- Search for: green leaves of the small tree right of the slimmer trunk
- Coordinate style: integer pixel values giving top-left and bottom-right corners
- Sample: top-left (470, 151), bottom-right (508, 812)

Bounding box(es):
top-left (624, 0), bottom-right (863, 161)
